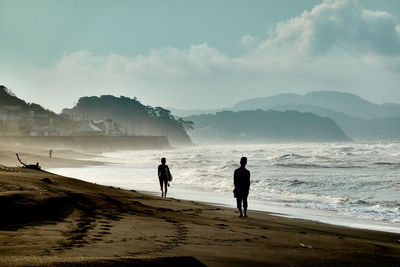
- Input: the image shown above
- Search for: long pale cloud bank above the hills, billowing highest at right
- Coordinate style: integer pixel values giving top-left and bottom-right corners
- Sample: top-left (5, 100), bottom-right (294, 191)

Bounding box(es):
top-left (17, 0), bottom-right (400, 109)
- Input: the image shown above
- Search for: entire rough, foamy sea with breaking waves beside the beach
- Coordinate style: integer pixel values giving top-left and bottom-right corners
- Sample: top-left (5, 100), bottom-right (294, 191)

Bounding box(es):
top-left (51, 142), bottom-right (400, 232)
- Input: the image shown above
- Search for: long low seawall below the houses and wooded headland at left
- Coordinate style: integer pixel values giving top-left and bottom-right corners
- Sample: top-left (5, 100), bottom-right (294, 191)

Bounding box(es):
top-left (0, 136), bottom-right (171, 151)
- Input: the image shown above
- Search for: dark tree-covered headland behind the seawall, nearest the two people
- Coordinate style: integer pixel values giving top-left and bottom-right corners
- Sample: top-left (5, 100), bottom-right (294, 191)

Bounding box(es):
top-left (63, 95), bottom-right (192, 144)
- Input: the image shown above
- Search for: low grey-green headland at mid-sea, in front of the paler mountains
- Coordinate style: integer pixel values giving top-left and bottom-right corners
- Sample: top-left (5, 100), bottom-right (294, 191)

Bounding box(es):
top-left (185, 110), bottom-right (351, 142)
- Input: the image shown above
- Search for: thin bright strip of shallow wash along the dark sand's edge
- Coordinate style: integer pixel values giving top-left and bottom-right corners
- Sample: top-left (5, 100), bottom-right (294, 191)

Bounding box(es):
top-left (50, 166), bottom-right (400, 233)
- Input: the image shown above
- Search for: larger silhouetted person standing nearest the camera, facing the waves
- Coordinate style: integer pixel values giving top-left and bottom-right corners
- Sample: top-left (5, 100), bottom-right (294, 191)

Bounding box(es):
top-left (233, 157), bottom-right (250, 217)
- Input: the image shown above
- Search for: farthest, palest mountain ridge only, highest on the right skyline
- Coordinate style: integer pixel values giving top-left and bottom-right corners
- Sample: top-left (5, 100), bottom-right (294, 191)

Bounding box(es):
top-left (232, 91), bottom-right (400, 120)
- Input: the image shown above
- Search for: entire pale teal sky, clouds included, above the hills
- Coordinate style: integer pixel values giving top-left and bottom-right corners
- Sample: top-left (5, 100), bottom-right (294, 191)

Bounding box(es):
top-left (0, 0), bottom-right (400, 112)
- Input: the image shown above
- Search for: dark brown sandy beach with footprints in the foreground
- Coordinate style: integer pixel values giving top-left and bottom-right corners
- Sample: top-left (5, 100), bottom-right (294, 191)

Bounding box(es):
top-left (0, 152), bottom-right (400, 266)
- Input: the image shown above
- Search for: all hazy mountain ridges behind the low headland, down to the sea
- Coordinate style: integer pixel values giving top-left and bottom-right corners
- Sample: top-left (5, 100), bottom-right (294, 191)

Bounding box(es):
top-left (174, 91), bottom-right (400, 141)
